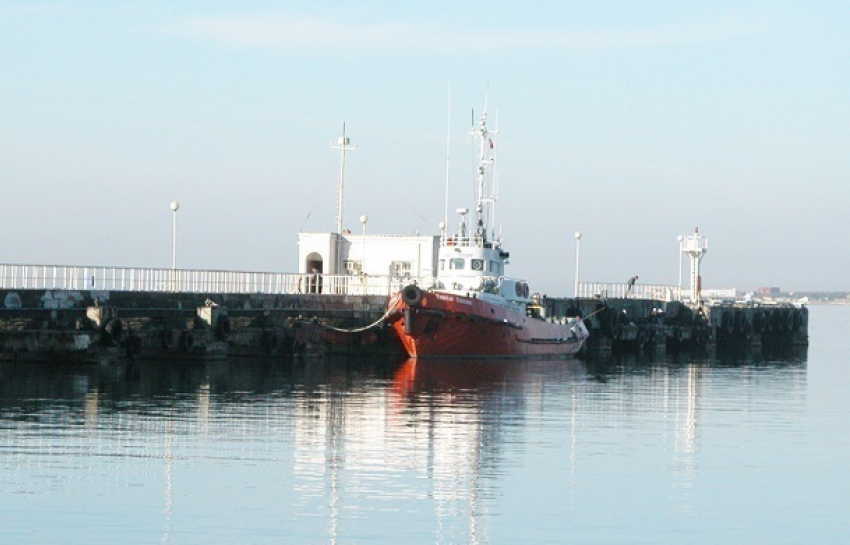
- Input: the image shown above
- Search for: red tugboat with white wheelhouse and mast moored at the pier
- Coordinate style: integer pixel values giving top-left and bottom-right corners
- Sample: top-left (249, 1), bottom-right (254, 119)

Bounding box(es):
top-left (387, 108), bottom-right (589, 358)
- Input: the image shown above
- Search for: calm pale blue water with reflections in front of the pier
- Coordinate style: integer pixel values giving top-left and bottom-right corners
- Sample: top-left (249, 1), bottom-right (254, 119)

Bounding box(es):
top-left (0, 307), bottom-right (850, 544)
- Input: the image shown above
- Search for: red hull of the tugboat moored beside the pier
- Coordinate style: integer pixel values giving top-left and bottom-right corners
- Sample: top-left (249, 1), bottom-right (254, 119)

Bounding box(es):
top-left (389, 292), bottom-right (587, 358)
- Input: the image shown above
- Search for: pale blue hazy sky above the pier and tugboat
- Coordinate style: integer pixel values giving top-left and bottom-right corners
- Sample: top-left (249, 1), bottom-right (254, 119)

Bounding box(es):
top-left (0, 0), bottom-right (850, 295)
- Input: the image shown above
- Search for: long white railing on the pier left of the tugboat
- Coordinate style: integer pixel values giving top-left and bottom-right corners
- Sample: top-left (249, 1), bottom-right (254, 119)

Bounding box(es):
top-left (0, 264), bottom-right (430, 296)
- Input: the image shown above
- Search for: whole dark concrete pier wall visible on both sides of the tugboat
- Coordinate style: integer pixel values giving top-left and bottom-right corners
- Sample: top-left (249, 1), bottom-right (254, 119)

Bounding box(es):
top-left (0, 290), bottom-right (808, 362)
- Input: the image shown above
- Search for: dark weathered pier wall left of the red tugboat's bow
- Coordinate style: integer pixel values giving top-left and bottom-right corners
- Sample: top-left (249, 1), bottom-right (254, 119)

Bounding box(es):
top-left (0, 290), bottom-right (391, 361)
